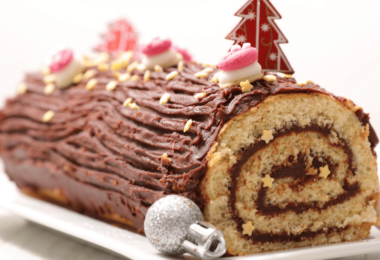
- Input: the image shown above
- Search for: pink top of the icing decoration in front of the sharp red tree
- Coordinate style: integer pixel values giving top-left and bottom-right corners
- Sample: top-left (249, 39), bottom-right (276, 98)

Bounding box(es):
top-left (218, 47), bottom-right (258, 71)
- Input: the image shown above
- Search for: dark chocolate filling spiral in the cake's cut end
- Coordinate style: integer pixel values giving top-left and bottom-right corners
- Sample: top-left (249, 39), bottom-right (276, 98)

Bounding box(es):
top-left (229, 123), bottom-right (360, 244)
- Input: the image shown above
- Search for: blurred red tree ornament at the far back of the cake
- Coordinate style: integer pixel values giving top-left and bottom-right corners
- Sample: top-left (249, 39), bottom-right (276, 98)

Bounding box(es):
top-left (95, 19), bottom-right (139, 57)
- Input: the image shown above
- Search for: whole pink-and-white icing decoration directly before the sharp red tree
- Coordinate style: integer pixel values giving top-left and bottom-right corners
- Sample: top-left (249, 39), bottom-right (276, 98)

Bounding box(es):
top-left (218, 43), bottom-right (263, 89)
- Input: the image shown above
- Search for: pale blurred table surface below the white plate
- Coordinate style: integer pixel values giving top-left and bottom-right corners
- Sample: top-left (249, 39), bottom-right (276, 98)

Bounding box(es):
top-left (0, 206), bottom-right (380, 260)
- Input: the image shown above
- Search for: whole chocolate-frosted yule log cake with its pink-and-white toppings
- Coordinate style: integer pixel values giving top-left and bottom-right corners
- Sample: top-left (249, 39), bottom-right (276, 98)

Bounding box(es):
top-left (0, 38), bottom-right (379, 255)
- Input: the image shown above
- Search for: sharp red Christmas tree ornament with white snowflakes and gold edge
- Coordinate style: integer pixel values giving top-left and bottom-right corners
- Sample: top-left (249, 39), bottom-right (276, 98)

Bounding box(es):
top-left (226, 0), bottom-right (294, 74)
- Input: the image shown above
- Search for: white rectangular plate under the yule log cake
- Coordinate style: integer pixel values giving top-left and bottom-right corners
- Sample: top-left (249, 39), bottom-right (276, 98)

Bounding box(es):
top-left (0, 172), bottom-right (380, 260)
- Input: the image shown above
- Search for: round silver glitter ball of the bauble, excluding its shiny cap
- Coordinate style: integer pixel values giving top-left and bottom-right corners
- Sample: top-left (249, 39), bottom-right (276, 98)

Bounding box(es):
top-left (144, 195), bottom-right (203, 255)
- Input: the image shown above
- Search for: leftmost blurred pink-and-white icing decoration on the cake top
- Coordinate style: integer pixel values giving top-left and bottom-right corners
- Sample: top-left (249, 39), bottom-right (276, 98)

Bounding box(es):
top-left (46, 49), bottom-right (85, 88)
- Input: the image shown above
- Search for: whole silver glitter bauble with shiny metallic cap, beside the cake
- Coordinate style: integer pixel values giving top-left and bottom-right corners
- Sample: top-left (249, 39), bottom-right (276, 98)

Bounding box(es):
top-left (144, 195), bottom-right (226, 260)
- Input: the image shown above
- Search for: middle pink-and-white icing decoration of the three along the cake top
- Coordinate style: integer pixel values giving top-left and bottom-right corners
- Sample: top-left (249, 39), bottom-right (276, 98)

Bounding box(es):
top-left (141, 37), bottom-right (183, 69)
